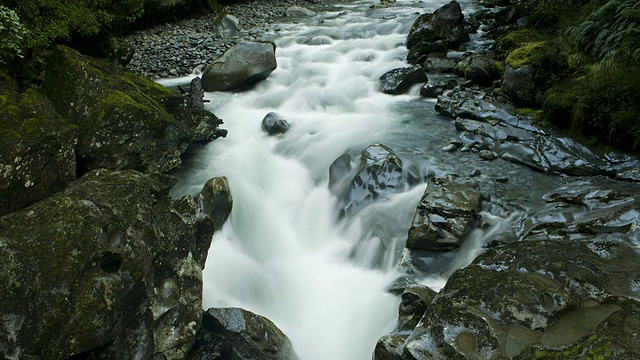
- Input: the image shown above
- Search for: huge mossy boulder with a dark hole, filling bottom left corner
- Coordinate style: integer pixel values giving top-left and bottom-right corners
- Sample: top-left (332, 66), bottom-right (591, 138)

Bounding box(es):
top-left (0, 170), bottom-right (230, 359)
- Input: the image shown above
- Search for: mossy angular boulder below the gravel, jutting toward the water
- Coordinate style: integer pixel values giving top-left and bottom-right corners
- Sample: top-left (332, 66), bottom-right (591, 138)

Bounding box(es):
top-left (43, 46), bottom-right (221, 172)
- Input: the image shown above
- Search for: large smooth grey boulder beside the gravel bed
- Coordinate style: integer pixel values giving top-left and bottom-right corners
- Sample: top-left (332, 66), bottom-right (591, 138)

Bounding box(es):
top-left (202, 41), bottom-right (277, 91)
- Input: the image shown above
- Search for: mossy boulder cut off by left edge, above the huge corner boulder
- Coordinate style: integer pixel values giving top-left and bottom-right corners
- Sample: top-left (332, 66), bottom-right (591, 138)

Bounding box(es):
top-left (0, 73), bottom-right (77, 216)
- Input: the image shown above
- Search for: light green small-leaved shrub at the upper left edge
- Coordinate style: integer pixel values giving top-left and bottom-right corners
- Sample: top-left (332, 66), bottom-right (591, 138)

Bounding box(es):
top-left (0, 5), bottom-right (26, 66)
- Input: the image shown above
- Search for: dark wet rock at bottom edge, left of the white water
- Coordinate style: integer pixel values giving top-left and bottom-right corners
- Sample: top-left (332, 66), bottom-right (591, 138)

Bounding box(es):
top-left (187, 308), bottom-right (298, 360)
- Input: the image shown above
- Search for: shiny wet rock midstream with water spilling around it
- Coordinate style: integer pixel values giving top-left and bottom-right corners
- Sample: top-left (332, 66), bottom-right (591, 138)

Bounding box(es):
top-left (329, 144), bottom-right (406, 214)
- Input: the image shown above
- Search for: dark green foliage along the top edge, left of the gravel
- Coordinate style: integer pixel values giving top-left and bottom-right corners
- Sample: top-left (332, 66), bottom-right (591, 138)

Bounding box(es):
top-left (15, 0), bottom-right (144, 48)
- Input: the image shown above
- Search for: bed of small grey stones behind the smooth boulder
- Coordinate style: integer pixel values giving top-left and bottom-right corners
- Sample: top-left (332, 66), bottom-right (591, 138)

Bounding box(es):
top-left (125, 0), bottom-right (341, 79)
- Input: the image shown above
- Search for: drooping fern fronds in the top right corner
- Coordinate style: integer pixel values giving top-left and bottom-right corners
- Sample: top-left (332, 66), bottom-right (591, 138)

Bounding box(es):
top-left (567, 0), bottom-right (640, 64)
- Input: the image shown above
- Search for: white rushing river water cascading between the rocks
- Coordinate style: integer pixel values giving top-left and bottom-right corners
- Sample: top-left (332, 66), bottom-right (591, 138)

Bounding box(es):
top-left (166, 0), bottom-right (556, 360)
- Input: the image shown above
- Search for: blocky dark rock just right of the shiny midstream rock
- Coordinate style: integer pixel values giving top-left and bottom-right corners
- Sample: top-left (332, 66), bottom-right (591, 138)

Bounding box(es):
top-left (406, 178), bottom-right (481, 251)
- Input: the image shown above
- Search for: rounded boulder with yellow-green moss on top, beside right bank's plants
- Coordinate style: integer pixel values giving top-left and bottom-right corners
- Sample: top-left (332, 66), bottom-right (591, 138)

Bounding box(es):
top-left (502, 41), bottom-right (567, 107)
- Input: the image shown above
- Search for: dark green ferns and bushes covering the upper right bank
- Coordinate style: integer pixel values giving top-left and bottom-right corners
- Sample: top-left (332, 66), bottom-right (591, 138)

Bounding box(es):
top-left (516, 0), bottom-right (640, 152)
